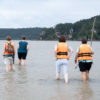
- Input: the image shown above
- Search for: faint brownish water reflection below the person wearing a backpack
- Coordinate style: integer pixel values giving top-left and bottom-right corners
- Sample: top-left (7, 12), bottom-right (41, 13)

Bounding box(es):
top-left (3, 72), bottom-right (16, 100)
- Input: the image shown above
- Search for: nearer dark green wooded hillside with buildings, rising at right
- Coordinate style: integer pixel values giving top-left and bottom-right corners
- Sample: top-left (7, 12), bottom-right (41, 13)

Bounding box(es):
top-left (41, 16), bottom-right (100, 40)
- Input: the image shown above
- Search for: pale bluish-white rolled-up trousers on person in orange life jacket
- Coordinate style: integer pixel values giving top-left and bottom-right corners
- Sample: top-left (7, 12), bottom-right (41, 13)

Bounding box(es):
top-left (56, 59), bottom-right (68, 75)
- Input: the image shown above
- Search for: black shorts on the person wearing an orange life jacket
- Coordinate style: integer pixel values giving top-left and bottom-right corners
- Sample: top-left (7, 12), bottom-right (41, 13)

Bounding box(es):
top-left (79, 62), bottom-right (92, 72)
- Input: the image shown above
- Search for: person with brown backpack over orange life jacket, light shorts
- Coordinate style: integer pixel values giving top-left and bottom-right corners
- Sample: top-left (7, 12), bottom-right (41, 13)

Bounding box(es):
top-left (3, 36), bottom-right (15, 72)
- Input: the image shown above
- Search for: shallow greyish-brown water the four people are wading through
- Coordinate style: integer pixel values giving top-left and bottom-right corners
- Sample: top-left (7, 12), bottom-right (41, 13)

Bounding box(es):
top-left (0, 41), bottom-right (100, 100)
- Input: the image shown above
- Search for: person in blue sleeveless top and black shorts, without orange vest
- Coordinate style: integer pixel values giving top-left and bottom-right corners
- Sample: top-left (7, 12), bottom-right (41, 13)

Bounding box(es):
top-left (17, 36), bottom-right (29, 66)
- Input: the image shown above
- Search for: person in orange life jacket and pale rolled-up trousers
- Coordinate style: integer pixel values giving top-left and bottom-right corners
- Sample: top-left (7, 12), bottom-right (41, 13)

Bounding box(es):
top-left (55, 36), bottom-right (73, 83)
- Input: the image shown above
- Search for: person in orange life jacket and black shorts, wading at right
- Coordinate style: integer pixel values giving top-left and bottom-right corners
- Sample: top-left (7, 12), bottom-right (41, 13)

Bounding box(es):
top-left (75, 38), bottom-right (94, 81)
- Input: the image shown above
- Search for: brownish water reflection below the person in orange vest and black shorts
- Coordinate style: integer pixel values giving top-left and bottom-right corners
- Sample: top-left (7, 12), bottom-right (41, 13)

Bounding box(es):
top-left (76, 82), bottom-right (94, 100)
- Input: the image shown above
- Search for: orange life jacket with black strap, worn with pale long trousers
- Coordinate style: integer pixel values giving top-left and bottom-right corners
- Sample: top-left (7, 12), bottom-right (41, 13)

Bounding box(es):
top-left (56, 42), bottom-right (69, 59)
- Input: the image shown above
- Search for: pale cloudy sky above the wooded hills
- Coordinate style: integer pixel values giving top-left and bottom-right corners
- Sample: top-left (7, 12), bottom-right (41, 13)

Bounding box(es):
top-left (0, 0), bottom-right (100, 28)
